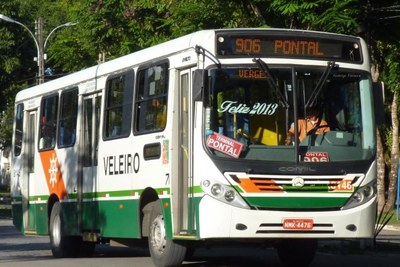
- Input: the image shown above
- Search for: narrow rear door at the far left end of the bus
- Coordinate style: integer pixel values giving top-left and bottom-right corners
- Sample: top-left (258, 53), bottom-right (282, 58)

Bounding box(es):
top-left (20, 110), bottom-right (37, 234)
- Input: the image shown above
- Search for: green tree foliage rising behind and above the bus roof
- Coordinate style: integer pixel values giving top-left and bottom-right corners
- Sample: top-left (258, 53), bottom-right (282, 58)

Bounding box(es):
top-left (0, 0), bottom-right (400, 207)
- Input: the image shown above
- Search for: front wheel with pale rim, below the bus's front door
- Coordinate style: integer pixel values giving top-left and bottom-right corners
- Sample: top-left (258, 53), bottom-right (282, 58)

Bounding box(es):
top-left (148, 200), bottom-right (186, 267)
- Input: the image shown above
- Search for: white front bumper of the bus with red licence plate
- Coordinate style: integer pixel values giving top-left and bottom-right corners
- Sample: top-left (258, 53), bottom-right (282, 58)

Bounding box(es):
top-left (198, 195), bottom-right (376, 239)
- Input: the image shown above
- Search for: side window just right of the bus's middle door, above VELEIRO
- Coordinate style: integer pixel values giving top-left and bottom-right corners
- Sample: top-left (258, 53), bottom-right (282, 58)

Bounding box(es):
top-left (104, 71), bottom-right (133, 139)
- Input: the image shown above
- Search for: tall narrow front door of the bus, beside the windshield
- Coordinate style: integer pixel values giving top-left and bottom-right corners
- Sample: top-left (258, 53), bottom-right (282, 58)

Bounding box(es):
top-left (173, 69), bottom-right (195, 235)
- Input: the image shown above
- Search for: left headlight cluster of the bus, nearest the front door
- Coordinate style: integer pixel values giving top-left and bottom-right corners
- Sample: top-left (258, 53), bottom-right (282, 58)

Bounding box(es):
top-left (201, 179), bottom-right (250, 209)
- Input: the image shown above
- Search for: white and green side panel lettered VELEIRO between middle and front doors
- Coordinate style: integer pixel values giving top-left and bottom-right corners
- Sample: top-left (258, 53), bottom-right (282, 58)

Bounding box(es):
top-left (97, 136), bottom-right (171, 238)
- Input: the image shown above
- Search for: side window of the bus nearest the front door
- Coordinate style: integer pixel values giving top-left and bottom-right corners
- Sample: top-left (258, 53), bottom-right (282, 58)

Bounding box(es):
top-left (135, 63), bottom-right (168, 133)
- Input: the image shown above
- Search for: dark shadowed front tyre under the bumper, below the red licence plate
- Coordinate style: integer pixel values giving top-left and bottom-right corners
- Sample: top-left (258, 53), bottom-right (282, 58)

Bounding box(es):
top-left (277, 239), bottom-right (318, 267)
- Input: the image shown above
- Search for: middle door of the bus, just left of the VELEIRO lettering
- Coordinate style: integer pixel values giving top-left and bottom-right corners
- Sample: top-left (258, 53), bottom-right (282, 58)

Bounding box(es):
top-left (78, 93), bottom-right (101, 231)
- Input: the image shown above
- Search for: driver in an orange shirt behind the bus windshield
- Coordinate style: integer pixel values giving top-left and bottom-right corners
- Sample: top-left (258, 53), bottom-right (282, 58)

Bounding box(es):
top-left (285, 107), bottom-right (330, 145)
